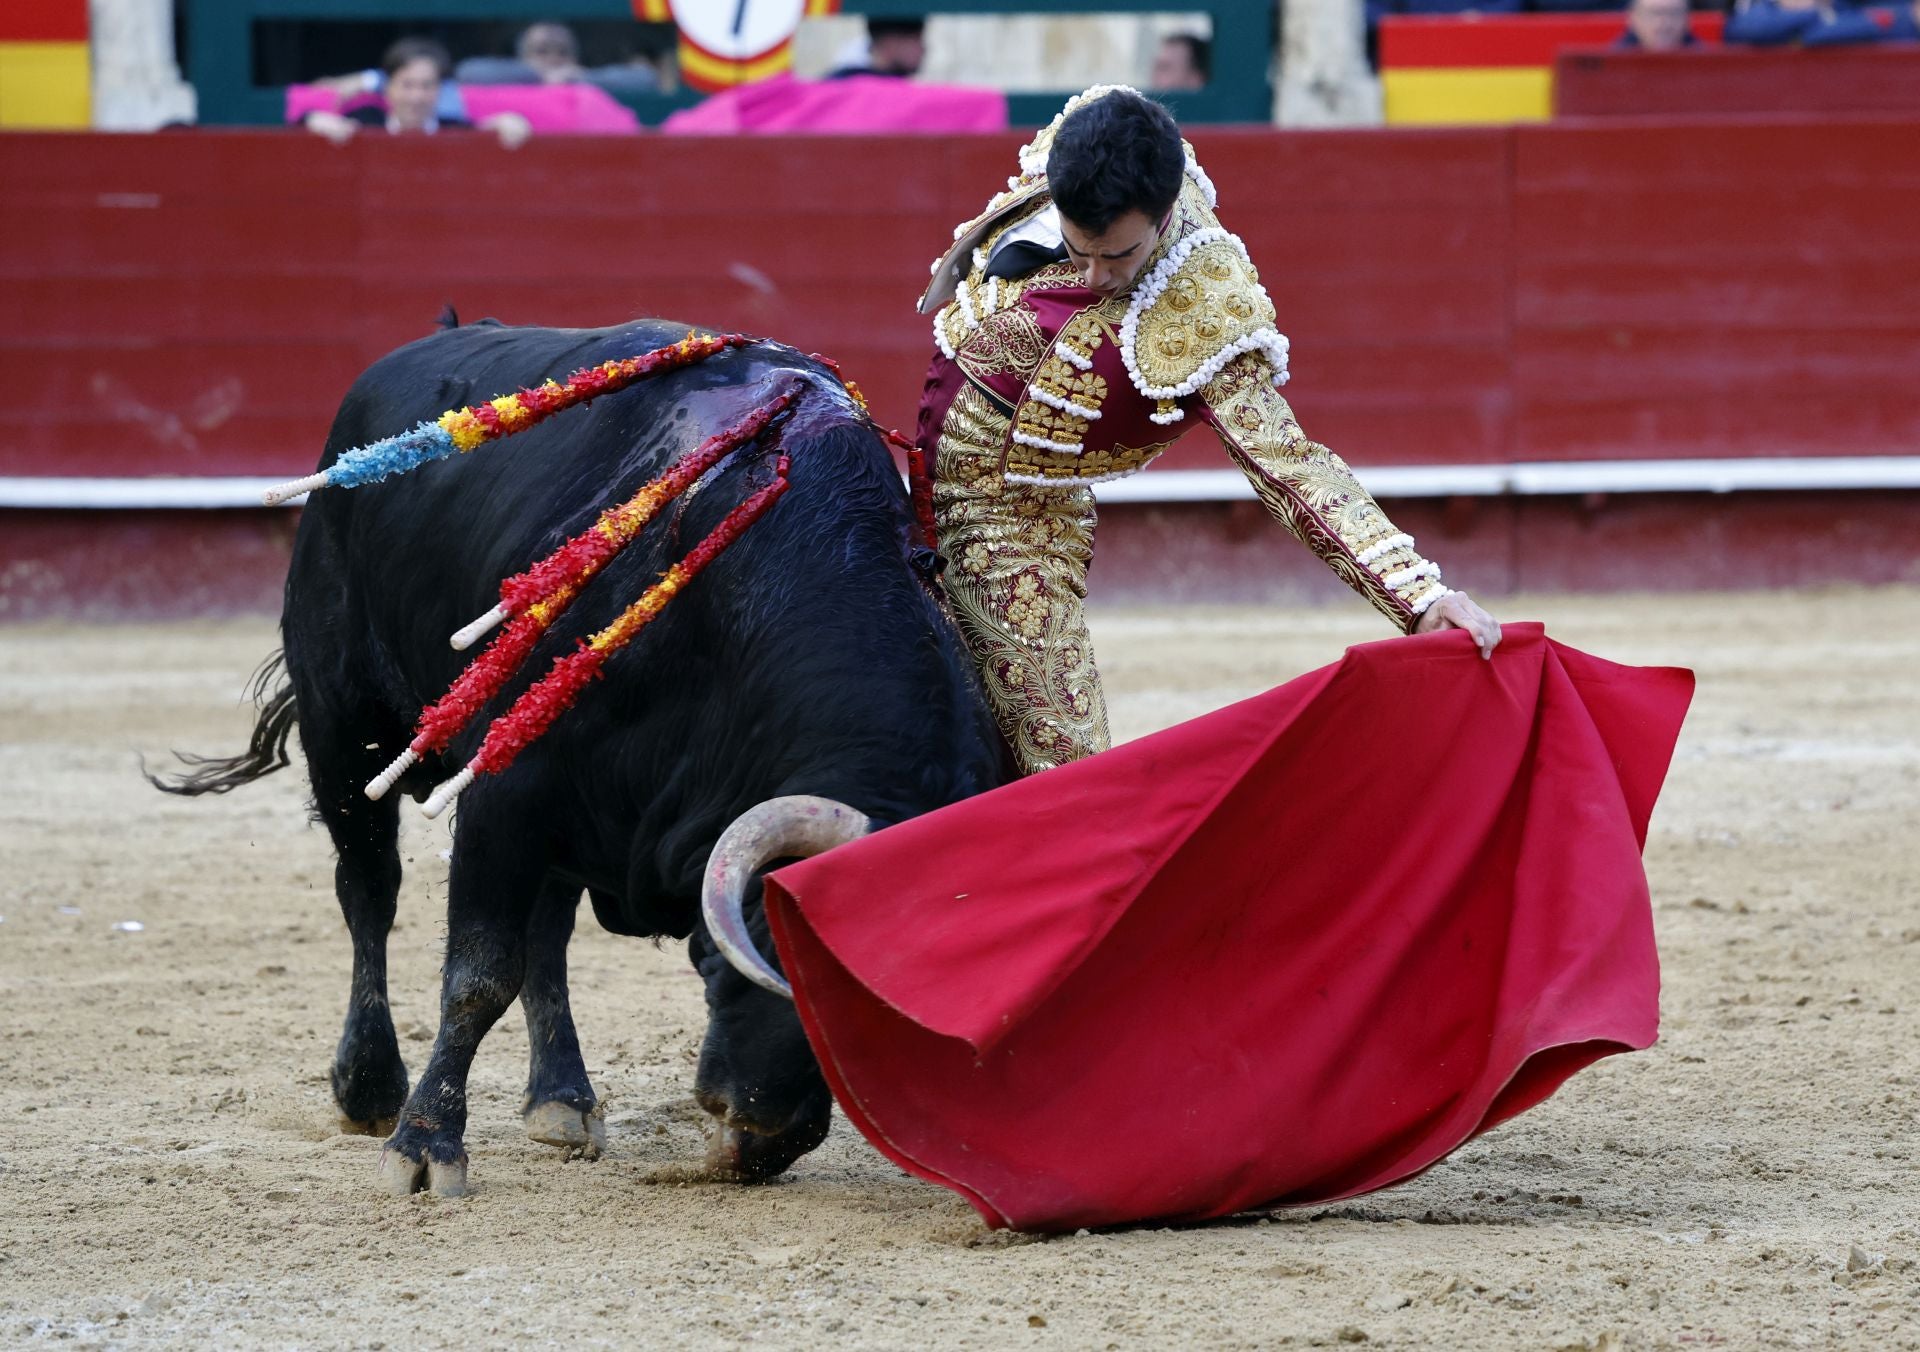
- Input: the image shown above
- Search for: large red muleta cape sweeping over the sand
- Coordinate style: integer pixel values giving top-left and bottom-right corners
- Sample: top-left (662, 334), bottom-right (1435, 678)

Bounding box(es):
top-left (766, 624), bottom-right (1693, 1229)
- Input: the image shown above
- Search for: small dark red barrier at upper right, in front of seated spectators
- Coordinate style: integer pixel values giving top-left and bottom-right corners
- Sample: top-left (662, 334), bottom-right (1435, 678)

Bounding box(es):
top-left (1553, 42), bottom-right (1920, 117)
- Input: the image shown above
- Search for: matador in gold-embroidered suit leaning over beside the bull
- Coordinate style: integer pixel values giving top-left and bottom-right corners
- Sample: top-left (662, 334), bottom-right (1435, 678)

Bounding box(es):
top-left (916, 86), bottom-right (1500, 774)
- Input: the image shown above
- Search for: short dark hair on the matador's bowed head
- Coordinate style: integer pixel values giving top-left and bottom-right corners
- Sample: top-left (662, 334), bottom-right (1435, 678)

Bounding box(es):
top-left (1046, 90), bottom-right (1187, 234)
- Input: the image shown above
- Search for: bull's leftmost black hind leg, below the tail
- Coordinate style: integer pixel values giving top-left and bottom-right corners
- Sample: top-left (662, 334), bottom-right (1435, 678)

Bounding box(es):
top-left (301, 733), bottom-right (407, 1135)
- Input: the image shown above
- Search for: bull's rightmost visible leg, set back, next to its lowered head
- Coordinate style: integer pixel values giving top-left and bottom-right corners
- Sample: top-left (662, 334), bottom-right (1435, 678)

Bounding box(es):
top-left (520, 880), bottom-right (607, 1160)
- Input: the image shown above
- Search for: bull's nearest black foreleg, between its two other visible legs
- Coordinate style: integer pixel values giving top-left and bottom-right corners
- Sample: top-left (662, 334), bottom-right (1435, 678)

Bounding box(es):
top-left (380, 806), bottom-right (545, 1196)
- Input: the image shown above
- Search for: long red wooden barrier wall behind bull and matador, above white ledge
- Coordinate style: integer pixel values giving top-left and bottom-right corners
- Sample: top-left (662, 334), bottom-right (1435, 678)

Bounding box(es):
top-left (0, 119), bottom-right (1920, 476)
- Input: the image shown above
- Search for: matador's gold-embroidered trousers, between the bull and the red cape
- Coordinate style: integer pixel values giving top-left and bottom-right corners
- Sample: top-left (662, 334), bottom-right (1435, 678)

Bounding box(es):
top-left (933, 386), bottom-right (1112, 774)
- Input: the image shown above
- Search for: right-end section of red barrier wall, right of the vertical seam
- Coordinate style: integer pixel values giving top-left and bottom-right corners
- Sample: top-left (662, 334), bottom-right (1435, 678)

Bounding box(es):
top-left (1513, 119), bottom-right (1920, 459)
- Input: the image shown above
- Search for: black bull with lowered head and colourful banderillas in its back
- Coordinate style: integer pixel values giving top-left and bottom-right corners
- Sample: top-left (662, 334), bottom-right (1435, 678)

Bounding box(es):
top-left (149, 323), bottom-right (1006, 1193)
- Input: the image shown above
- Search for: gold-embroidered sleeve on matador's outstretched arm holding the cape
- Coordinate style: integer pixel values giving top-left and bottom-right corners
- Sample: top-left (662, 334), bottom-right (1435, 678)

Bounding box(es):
top-left (1200, 353), bottom-right (1450, 632)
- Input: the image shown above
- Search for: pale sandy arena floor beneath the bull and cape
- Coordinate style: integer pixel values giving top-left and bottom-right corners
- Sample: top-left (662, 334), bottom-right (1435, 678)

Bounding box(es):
top-left (0, 590), bottom-right (1920, 1352)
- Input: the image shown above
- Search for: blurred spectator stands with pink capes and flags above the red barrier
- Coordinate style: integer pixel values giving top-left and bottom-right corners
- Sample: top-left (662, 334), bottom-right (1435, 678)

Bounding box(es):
top-left (18, 0), bottom-right (1920, 144)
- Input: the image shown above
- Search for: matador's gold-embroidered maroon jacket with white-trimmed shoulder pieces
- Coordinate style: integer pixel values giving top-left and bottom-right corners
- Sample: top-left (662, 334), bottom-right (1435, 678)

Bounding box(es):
top-left (920, 86), bottom-right (1448, 630)
